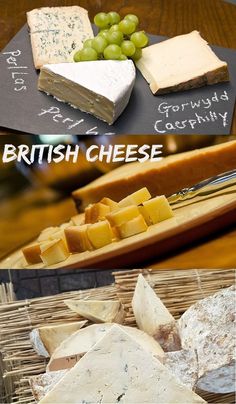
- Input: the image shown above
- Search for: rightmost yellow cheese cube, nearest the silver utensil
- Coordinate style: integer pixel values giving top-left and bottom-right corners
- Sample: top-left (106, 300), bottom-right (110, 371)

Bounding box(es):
top-left (141, 195), bottom-right (174, 224)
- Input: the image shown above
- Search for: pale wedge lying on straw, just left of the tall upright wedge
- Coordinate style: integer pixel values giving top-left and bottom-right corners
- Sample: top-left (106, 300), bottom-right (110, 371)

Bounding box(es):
top-left (64, 300), bottom-right (125, 324)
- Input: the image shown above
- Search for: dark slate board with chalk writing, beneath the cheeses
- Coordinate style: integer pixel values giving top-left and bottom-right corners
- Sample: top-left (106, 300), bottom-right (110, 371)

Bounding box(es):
top-left (0, 25), bottom-right (236, 135)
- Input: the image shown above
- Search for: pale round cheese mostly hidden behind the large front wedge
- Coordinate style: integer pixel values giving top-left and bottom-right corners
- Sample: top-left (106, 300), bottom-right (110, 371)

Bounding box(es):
top-left (47, 323), bottom-right (165, 371)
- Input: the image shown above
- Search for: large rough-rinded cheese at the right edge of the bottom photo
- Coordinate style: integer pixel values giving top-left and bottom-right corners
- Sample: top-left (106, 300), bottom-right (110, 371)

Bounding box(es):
top-left (179, 286), bottom-right (236, 393)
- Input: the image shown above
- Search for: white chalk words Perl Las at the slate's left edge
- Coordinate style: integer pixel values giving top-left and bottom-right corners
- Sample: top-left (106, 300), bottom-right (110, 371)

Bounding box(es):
top-left (3, 49), bottom-right (29, 92)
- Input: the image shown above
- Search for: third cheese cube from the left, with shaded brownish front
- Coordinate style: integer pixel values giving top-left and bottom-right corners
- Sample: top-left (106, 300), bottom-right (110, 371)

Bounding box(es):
top-left (65, 224), bottom-right (93, 253)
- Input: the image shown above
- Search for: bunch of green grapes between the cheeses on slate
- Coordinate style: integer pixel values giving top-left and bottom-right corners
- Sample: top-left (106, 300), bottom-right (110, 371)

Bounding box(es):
top-left (74, 11), bottom-right (148, 62)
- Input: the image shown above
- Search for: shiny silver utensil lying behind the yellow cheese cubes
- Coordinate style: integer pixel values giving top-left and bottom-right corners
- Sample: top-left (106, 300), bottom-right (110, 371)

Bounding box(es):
top-left (168, 170), bottom-right (236, 205)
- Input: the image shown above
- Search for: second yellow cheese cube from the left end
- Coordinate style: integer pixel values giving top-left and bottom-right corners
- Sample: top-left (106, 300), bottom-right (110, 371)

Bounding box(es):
top-left (40, 240), bottom-right (70, 266)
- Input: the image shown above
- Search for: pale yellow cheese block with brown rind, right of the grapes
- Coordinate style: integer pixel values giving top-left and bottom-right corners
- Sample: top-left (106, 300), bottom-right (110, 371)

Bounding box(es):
top-left (136, 31), bottom-right (229, 94)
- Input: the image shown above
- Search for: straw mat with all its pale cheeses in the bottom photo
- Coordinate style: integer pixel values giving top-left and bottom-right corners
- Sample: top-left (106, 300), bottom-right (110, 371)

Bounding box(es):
top-left (0, 270), bottom-right (235, 404)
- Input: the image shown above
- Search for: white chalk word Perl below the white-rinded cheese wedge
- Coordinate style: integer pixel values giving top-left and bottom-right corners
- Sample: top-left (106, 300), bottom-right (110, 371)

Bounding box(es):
top-left (38, 106), bottom-right (115, 135)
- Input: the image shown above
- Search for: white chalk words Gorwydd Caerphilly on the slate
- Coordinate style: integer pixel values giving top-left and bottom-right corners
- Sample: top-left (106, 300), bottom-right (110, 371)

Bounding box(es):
top-left (154, 91), bottom-right (229, 133)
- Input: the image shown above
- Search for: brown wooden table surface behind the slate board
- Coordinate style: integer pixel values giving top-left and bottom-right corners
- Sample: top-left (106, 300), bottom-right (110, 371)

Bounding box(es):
top-left (0, 0), bottom-right (236, 133)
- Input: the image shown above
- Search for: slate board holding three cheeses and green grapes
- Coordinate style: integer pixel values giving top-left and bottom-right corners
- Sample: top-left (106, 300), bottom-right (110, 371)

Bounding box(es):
top-left (0, 6), bottom-right (236, 134)
